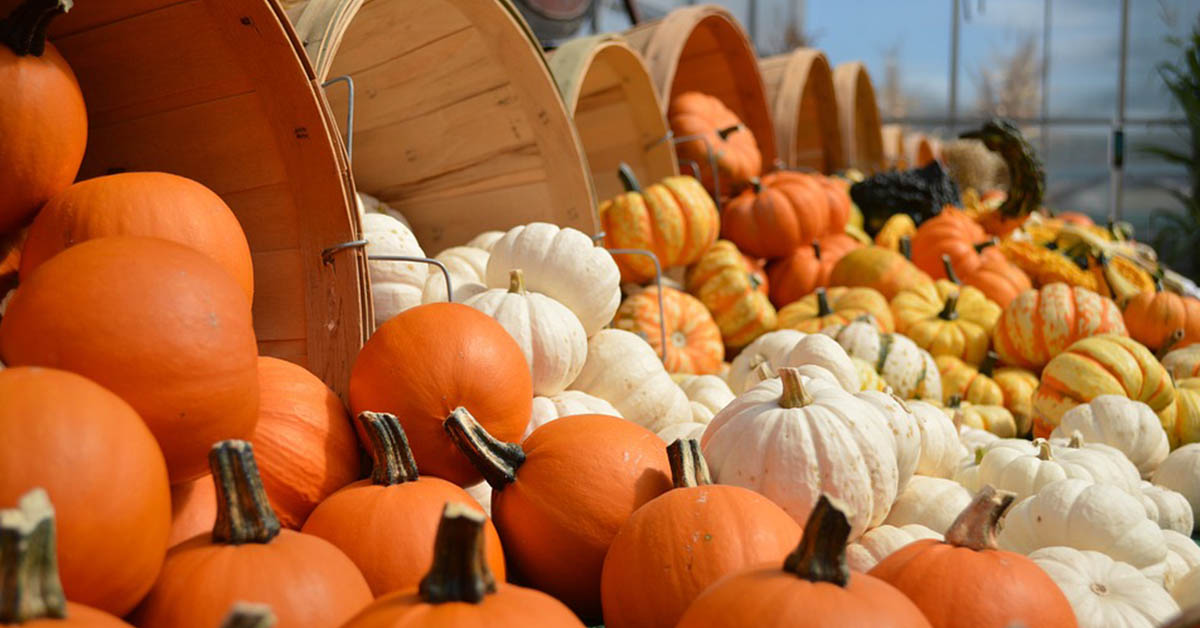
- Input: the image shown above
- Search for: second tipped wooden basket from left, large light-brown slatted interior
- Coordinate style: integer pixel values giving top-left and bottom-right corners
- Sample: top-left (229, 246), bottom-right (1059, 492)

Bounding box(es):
top-left (290, 0), bottom-right (598, 255)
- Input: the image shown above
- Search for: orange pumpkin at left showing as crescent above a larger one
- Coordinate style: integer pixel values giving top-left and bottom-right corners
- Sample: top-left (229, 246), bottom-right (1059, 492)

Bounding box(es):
top-left (20, 172), bottom-right (254, 301)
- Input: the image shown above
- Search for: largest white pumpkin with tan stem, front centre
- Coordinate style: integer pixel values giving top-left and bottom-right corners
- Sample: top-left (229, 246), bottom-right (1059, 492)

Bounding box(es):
top-left (702, 367), bottom-right (899, 539)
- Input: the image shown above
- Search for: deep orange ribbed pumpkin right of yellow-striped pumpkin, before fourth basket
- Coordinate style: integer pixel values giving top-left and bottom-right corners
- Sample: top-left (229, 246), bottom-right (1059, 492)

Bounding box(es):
top-left (721, 171), bottom-right (850, 259)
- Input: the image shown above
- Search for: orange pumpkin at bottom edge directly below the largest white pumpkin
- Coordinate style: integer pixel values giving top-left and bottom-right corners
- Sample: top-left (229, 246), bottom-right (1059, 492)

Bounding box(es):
top-left (678, 495), bottom-right (929, 628)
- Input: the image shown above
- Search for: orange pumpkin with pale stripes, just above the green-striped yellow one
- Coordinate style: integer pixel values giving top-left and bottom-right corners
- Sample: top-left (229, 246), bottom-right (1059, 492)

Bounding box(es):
top-left (992, 283), bottom-right (1128, 371)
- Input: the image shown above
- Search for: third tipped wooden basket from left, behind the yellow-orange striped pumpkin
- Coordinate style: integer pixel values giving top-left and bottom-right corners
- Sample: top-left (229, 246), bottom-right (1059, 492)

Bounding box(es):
top-left (548, 35), bottom-right (679, 201)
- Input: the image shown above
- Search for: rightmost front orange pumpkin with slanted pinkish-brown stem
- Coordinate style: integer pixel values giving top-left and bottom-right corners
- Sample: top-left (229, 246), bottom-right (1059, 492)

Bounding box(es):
top-left (870, 486), bottom-right (1076, 628)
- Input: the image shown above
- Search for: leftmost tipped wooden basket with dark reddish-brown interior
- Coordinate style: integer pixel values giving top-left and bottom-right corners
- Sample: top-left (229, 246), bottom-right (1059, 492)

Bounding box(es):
top-left (0, 0), bottom-right (371, 395)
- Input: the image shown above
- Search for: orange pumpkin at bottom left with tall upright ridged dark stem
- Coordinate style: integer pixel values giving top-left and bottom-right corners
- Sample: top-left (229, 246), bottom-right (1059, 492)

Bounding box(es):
top-left (131, 441), bottom-right (372, 628)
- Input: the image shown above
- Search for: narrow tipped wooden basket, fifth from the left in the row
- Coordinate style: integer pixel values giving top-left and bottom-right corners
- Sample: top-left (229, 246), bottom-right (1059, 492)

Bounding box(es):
top-left (758, 48), bottom-right (845, 174)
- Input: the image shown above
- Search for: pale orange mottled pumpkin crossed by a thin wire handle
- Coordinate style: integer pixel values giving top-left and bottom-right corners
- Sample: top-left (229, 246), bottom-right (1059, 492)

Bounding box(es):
top-left (612, 286), bottom-right (725, 375)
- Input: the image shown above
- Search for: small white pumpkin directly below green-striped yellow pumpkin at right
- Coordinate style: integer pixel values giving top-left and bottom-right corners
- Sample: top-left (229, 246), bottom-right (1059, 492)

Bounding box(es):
top-left (1050, 395), bottom-right (1170, 478)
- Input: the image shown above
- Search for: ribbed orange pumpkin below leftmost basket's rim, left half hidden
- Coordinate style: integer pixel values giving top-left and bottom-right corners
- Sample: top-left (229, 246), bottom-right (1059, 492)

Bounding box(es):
top-left (251, 357), bottom-right (359, 530)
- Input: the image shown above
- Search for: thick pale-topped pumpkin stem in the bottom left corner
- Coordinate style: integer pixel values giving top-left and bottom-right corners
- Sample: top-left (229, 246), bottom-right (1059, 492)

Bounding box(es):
top-left (0, 489), bottom-right (67, 626)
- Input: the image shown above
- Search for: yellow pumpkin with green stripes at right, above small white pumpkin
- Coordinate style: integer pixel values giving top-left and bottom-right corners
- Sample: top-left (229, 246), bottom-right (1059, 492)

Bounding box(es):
top-left (1033, 334), bottom-right (1178, 445)
